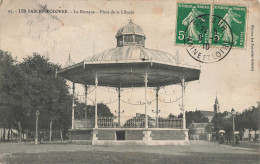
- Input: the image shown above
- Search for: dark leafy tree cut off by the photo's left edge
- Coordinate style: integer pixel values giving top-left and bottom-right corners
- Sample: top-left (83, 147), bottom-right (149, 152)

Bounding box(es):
top-left (0, 50), bottom-right (30, 140)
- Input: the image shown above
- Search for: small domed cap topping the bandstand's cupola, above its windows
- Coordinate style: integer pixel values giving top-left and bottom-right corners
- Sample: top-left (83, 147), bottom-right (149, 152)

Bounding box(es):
top-left (116, 20), bottom-right (145, 37)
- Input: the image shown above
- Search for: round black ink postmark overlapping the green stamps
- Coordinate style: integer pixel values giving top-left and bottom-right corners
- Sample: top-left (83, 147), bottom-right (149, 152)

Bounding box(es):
top-left (184, 14), bottom-right (233, 63)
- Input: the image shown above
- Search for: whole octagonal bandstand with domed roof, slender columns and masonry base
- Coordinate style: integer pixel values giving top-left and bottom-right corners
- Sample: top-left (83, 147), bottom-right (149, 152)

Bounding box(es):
top-left (58, 21), bottom-right (200, 145)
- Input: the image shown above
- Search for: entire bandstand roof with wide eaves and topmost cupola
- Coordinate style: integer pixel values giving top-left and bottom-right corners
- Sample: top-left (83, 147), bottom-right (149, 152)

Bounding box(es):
top-left (58, 21), bottom-right (200, 88)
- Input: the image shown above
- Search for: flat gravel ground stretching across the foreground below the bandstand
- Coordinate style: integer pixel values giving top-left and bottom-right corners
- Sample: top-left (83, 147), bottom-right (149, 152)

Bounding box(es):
top-left (0, 141), bottom-right (260, 164)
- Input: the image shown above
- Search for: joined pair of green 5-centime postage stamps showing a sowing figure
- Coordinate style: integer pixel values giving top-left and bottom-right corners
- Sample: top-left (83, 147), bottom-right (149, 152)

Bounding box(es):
top-left (176, 3), bottom-right (247, 48)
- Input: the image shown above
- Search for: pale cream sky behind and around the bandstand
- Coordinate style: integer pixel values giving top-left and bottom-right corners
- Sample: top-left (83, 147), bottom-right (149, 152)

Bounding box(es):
top-left (0, 0), bottom-right (260, 120)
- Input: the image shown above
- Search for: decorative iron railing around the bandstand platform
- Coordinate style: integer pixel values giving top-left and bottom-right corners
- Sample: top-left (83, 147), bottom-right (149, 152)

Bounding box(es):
top-left (74, 117), bottom-right (183, 129)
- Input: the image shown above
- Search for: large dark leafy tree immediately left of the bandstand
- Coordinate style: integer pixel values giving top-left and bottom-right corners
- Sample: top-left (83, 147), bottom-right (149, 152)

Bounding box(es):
top-left (19, 53), bottom-right (72, 140)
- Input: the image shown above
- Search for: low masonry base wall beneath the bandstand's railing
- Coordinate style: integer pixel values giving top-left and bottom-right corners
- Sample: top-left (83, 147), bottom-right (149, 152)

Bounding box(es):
top-left (69, 128), bottom-right (189, 145)
